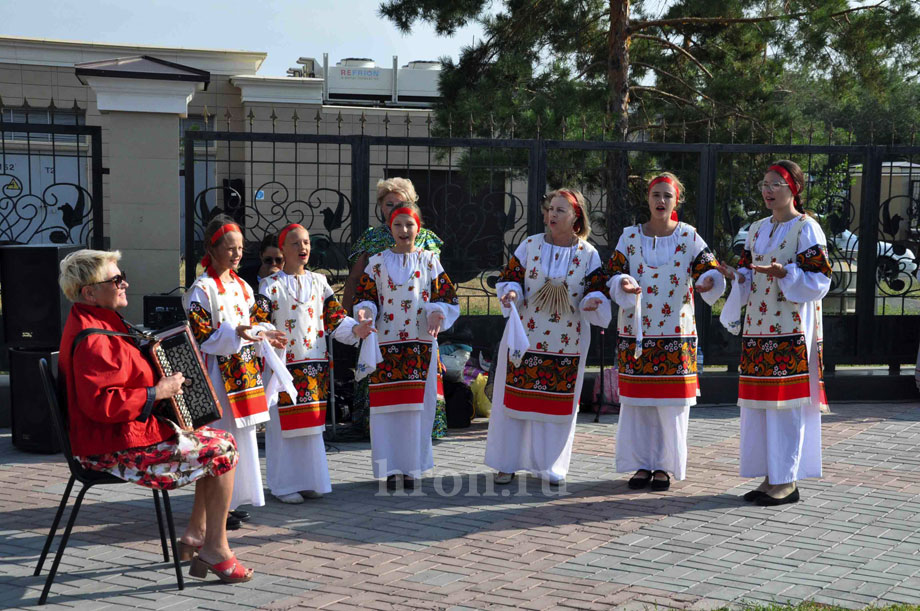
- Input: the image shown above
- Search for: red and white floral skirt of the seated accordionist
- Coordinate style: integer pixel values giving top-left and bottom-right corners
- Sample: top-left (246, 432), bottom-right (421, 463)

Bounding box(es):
top-left (74, 427), bottom-right (239, 490)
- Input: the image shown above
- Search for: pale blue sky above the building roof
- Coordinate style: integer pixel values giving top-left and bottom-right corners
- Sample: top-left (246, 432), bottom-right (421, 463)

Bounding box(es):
top-left (0, 0), bottom-right (481, 76)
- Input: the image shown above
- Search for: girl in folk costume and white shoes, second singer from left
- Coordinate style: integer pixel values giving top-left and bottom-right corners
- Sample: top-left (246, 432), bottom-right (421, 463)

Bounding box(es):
top-left (256, 224), bottom-right (371, 503)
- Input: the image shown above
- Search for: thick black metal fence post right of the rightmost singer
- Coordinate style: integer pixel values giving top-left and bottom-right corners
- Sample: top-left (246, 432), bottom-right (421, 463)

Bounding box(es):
top-left (856, 146), bottom-right (882, 363)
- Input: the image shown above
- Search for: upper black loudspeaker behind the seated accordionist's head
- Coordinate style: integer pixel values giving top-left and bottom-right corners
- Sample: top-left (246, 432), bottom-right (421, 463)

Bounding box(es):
top-left (0, 244), bottom-right (82, 348)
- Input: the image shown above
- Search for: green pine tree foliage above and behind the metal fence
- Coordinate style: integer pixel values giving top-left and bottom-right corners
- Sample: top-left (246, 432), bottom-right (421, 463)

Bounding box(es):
top-left (380, 0), bottom-right (920, 241)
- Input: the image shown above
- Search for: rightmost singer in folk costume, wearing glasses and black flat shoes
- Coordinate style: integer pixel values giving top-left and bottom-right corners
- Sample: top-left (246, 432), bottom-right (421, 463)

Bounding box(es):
top-left (720, 160), bottom-right (831, 505)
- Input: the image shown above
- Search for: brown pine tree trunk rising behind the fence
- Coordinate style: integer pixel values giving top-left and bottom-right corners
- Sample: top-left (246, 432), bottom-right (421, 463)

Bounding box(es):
top-left (607, 0), bottom-right (630, 249)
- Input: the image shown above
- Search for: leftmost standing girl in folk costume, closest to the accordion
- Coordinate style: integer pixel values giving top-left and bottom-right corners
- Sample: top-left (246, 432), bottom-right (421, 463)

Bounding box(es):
top-left (183, 215), bottom-right (285, 515)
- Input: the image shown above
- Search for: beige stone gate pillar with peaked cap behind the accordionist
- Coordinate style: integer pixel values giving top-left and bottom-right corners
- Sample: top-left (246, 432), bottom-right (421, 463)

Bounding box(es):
top-left (76, 67), bottom-right (210, 324)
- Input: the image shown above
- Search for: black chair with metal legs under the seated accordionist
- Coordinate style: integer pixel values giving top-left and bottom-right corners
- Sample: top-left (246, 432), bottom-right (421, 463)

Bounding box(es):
top-left (34, 359), bottom-right (185, 605)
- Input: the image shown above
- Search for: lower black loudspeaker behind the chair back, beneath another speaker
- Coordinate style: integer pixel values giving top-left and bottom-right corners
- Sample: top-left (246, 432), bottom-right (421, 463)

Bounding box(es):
top-left (10, 348), bottom-right (61, 454)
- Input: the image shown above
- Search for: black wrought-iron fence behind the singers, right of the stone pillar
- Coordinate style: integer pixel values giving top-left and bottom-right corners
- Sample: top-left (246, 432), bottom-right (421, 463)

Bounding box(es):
top-left (174, 111), bottom-right (920, 369)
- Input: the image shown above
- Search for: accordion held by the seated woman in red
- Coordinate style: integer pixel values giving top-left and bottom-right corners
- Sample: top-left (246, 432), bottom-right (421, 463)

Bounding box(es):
top-left (146, 322), bottom-right (221, 430)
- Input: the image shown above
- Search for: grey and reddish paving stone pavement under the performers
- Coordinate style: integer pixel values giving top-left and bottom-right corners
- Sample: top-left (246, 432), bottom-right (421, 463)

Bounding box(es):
top-left (0, 403), bottom-right (920, 611)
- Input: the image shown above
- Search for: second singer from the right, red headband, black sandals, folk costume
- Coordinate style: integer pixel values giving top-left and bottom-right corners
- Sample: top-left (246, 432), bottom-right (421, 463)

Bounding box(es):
top-left (606, 172), bottom-right (725, 490)
